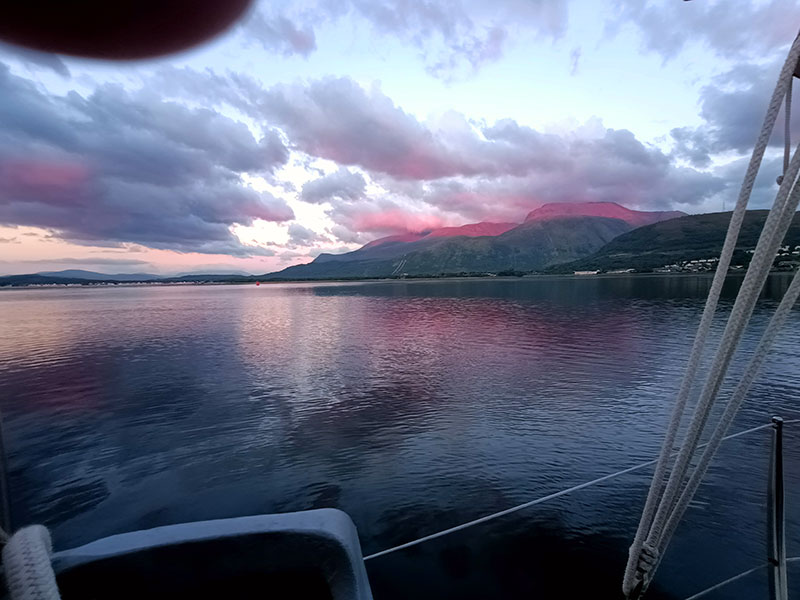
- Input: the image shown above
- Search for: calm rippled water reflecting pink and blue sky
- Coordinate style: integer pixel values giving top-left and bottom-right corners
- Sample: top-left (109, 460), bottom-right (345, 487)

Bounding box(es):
top-left (0, 276), bottom-right (800, 600)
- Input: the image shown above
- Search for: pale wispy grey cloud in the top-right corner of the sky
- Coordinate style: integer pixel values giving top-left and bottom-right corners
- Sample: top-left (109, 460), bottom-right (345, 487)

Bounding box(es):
top-left (607, 0), bottom-right (800, 58)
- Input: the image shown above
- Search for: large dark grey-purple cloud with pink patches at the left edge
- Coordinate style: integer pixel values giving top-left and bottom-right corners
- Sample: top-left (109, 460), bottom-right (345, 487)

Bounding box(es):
top-left (0, 64), bottom-right (294, 255)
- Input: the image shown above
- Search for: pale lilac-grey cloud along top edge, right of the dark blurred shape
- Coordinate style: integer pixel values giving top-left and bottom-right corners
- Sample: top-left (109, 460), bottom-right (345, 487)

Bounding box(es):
top-left (239, 0), bottom-right (569, 79)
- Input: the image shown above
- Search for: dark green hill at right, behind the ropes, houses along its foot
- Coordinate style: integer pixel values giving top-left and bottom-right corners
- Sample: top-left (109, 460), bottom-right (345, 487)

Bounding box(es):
top-left (548, 210), bottom-right (800, 273)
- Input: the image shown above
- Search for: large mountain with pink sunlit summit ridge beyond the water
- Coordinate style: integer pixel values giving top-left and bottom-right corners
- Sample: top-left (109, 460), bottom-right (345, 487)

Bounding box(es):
top-left (263, 202), bottom-right (684, 280)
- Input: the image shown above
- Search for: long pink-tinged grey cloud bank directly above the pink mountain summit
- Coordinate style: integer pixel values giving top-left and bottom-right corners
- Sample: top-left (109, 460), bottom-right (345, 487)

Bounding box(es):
top-left (248, 78), bottom-right (729, 236)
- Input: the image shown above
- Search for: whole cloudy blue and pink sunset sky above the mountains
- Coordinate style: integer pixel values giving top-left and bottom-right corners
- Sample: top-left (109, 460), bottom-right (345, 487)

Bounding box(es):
top-left (0, 0), bottom-right (800, 275)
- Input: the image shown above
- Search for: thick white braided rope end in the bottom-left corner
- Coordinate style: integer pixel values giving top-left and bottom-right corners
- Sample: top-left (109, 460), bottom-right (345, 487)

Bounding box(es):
top-left (3, 525), bottom-right (61, 600)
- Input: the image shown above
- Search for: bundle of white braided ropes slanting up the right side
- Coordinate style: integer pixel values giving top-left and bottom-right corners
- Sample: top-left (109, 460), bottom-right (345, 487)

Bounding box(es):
top-left (622, 29), bottom-right (800, 598)
